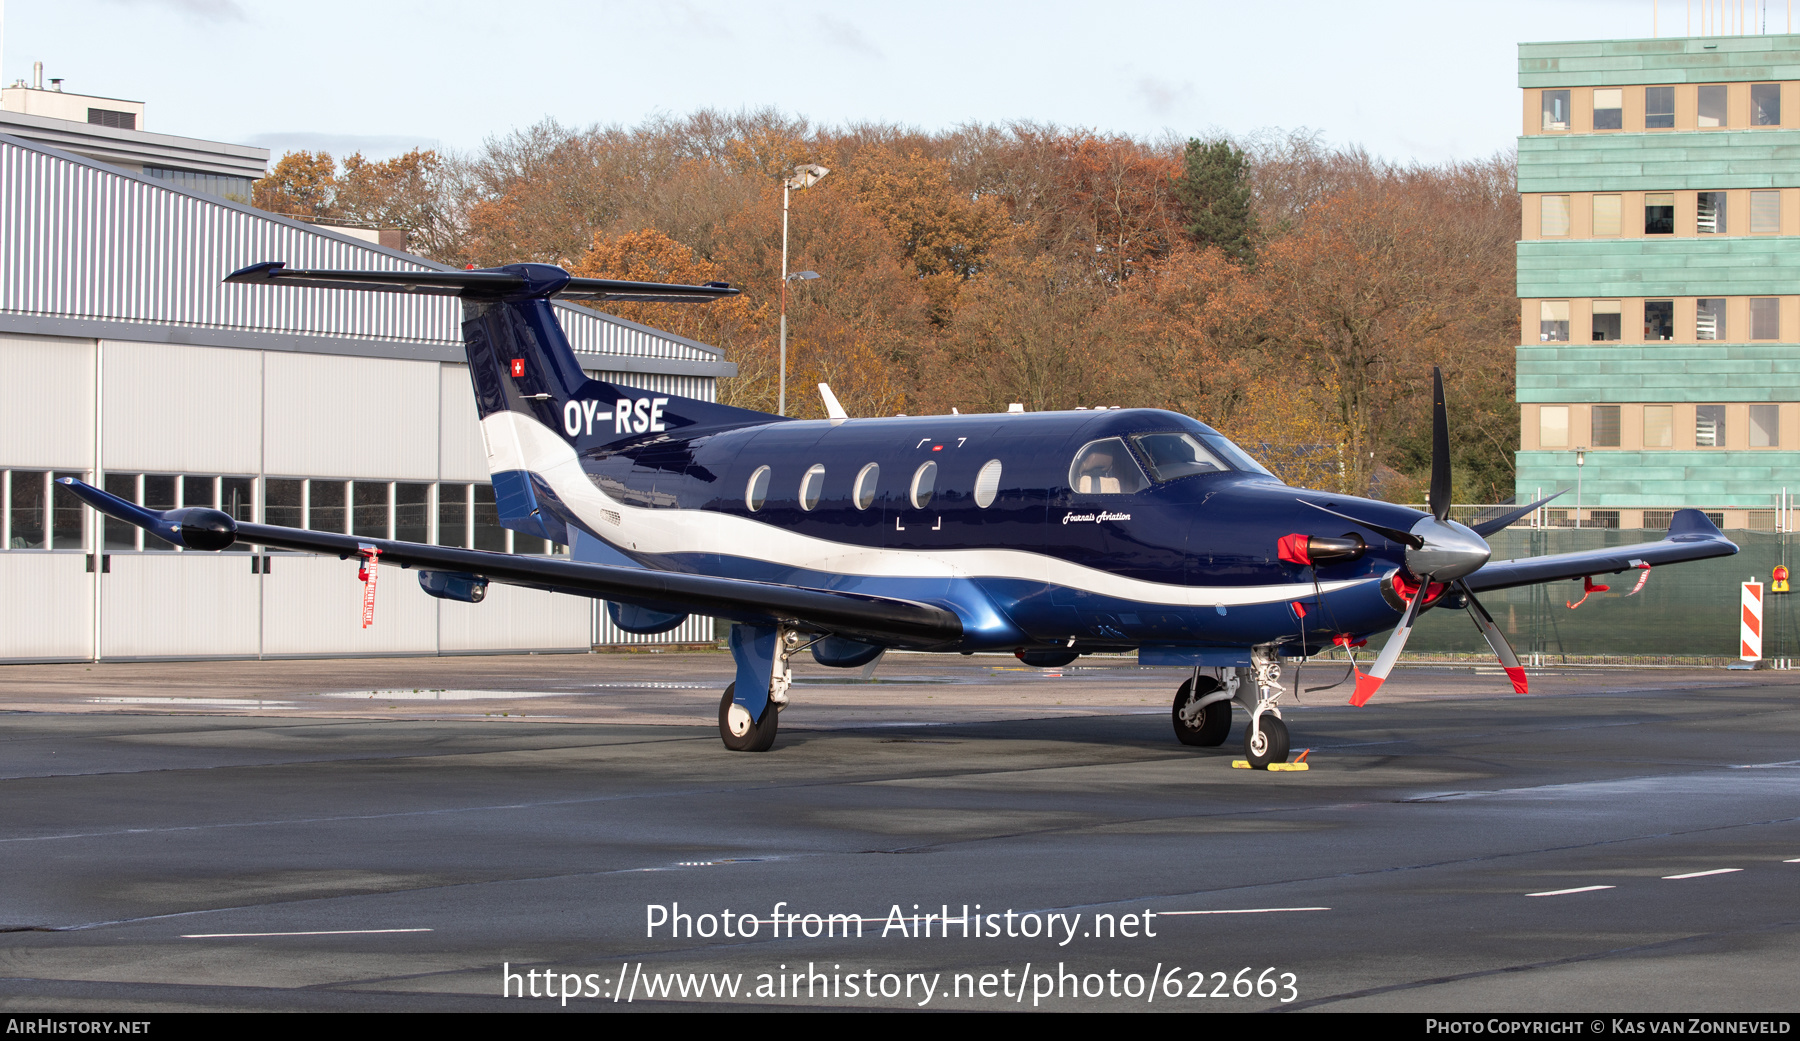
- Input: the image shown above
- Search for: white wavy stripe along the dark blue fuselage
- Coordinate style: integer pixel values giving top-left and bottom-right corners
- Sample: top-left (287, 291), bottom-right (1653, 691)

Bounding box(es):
top-left (481, 412), bottom-right (1373, 607)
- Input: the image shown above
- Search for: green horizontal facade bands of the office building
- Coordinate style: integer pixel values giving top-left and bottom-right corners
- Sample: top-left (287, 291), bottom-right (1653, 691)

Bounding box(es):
top-left (1517, 32), bottom-right (1800, 511)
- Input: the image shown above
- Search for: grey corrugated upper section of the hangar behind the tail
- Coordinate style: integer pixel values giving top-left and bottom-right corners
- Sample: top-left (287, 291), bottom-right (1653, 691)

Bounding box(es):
top-left (0, 135), bottom-right (736, 376)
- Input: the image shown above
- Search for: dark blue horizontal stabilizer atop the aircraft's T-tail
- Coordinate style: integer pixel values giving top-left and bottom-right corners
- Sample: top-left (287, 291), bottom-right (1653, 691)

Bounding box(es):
top-left (225, 261), bottom-right (740, 303)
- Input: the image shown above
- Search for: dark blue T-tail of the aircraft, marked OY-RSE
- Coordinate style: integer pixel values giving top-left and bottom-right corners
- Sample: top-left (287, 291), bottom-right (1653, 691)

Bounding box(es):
top-left (225, 263), bottom-right (779, 544)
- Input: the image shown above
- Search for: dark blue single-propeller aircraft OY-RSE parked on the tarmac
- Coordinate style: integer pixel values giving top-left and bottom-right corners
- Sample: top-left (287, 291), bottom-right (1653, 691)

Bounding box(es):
top-left (65, 263), bottom-right (1737, 767)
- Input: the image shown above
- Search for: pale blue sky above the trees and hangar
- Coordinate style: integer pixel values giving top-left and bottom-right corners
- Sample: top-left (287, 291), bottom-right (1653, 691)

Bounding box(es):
top-left (0, 0), bottom-right (1756, 164)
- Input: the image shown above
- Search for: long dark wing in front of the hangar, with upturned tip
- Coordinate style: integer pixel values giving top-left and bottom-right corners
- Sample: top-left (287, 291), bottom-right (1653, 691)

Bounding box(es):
top-left (61, 477), bottom-right (963, 648)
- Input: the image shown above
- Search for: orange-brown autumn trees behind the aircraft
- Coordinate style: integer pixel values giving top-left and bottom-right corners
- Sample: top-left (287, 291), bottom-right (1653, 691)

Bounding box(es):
top-left (256, 112), bottom-right (1519, 501)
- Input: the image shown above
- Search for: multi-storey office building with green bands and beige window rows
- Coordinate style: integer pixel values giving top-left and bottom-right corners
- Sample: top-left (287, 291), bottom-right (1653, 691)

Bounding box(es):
top-left (1517, 36), bottom-right (1800, 528)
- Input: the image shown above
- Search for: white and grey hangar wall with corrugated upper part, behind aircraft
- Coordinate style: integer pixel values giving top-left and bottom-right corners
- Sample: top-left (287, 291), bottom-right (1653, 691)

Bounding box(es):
top-left (0, 137), bottom-right (733, 661)
